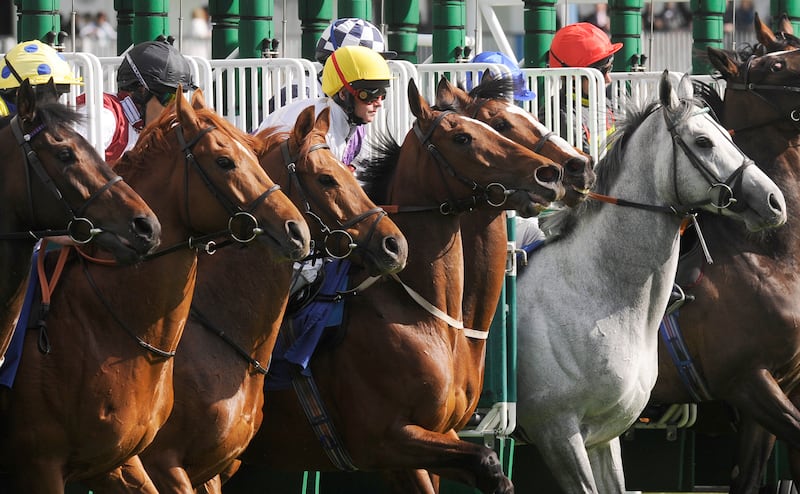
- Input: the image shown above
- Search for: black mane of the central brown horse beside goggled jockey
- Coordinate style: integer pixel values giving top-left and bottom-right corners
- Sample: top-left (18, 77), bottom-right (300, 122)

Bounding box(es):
top-left (355, 132), bottom-right (400, 204)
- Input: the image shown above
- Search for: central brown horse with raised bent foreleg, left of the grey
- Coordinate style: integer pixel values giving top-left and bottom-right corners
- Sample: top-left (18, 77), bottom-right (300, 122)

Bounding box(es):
top-left (236, 81), bottom-right (563, 493)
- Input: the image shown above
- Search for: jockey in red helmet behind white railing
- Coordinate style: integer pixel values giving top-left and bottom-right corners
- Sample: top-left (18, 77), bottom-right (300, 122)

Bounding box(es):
top-left (549, 22), bottom-right (622, 153)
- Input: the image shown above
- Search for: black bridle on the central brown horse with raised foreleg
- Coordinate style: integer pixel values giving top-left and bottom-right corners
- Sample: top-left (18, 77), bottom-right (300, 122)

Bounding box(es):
top-left (412, 110), bottom-right (564, 215)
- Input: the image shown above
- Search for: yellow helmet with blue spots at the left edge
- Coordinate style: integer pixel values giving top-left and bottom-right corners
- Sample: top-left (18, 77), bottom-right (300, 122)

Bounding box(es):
top-left (0, 40), bottom-right (83, 90)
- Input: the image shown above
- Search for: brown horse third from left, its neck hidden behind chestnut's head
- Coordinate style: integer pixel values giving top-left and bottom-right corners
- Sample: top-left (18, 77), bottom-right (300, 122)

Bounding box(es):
top-left (121, 105), bottom-right (408, 494)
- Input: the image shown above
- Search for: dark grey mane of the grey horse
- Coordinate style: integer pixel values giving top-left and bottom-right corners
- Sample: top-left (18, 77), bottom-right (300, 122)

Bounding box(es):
top-left (539, 96), bottom-right (701, 239)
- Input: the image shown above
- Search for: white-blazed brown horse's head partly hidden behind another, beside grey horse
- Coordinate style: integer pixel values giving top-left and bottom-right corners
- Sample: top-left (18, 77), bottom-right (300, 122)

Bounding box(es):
top-left (444, 69), bottom-right (595, 206)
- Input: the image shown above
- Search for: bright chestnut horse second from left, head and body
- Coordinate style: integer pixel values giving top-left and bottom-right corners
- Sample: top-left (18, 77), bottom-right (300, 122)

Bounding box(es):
top-left (2, 87), bottom-right (310, 494)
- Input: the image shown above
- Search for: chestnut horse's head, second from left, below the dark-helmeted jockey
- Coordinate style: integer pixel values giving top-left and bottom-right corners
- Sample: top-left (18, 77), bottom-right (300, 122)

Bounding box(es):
top-left (128, 88), bottom-right (310, 260)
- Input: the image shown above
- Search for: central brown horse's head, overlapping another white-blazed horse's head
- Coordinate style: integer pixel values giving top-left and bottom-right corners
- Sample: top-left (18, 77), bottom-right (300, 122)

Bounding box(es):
top-left (404, 80), bottom-right (565, 217)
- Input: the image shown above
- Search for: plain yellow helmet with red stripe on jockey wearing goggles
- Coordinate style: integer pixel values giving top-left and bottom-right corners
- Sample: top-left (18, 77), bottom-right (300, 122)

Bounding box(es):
top-left (322, 45), bottom-right (392, 97)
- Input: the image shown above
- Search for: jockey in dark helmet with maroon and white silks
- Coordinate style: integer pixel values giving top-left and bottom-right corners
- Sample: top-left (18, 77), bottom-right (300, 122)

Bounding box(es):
top-left (78, 40), bottom-right (197, 163)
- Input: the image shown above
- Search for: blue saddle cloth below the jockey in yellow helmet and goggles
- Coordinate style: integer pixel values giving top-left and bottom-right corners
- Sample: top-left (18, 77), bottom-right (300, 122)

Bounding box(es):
top-left (265, 260), bottom-right (350, 390)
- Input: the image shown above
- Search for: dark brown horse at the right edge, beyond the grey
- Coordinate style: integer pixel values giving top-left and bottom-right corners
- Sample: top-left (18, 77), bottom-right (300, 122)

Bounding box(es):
top-left (651, 18), bottom-right (800, 493)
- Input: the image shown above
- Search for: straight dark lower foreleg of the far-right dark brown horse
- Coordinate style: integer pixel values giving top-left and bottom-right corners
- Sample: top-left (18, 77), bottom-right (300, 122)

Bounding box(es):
top-left (730, 415), bottom-right (775, 494)
